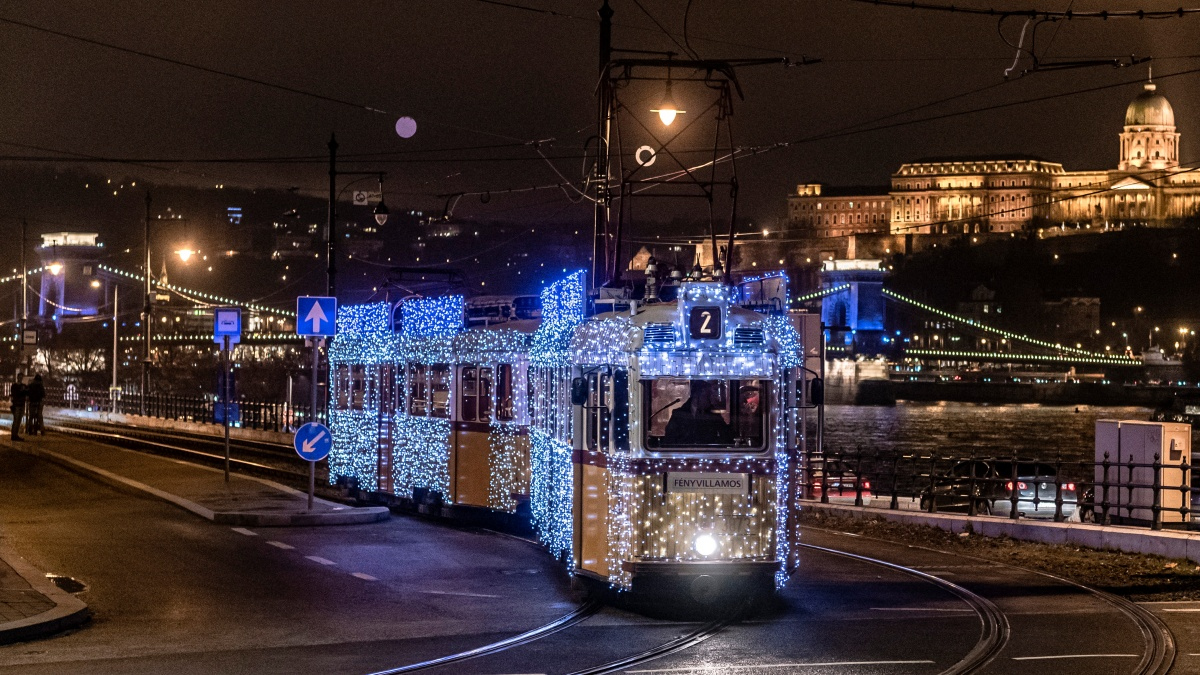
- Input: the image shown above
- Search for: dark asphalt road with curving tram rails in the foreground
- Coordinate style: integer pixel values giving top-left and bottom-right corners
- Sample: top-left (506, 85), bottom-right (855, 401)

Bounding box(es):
top-left (0, 439), bottom-right (1200, 675)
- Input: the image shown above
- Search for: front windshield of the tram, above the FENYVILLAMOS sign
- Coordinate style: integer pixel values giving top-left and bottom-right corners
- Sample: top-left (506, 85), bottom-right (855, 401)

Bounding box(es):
top-left (642, 377), bottom-right (768, 450)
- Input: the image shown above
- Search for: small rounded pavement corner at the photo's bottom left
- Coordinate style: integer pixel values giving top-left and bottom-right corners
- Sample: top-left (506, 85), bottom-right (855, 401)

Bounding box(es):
top-left (0, 540), bottom-right (91, 645)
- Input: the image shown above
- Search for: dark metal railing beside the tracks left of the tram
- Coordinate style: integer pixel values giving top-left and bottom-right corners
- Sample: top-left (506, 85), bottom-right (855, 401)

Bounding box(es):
top-left (46, 387), bottom-right (324, 431)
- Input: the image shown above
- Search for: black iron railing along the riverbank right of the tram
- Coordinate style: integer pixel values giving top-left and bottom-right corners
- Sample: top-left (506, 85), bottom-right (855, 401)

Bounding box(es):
top-left (800, 450), bottom-right (1200, 530)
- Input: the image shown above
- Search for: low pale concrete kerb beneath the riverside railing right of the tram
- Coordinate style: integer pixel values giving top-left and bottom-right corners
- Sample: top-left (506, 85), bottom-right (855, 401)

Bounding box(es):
top-left (800, 500), bottom-right (1200, 563)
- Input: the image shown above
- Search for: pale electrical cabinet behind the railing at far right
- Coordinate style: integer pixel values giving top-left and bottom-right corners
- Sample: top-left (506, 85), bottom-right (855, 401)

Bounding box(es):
top-left (1096, 419), bottom-right (1192, 524)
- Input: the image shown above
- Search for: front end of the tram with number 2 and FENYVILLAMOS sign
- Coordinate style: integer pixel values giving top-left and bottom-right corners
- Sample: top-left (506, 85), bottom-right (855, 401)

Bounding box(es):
top-left (572, 282), bottom-right (797, 604)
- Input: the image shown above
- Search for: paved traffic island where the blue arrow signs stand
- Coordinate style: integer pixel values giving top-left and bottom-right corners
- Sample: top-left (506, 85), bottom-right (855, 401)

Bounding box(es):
top-left (0, 430), bottom-right (391, 527)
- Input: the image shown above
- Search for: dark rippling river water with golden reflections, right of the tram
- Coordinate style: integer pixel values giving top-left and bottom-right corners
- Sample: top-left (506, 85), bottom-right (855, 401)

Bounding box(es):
top-left (824, 402), bottom-right (1152, 460)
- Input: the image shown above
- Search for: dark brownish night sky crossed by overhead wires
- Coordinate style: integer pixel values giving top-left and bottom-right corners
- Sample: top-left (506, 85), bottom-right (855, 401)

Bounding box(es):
top-left (0, 0), bottom-right (1200, 223)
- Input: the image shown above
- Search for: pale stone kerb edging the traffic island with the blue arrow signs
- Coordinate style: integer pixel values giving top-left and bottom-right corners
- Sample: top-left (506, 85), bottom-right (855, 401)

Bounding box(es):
top-left (8, 443), bottom-right (391, 527)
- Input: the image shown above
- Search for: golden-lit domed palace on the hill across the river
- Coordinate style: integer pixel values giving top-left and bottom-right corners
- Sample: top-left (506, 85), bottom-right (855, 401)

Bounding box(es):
top-left (787, 83), bottom-right (1200, 238)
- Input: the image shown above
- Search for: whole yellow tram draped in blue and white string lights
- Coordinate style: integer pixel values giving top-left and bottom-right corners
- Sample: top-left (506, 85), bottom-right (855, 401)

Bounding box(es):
top-left (329, 273), bottom-right (816, 603)
